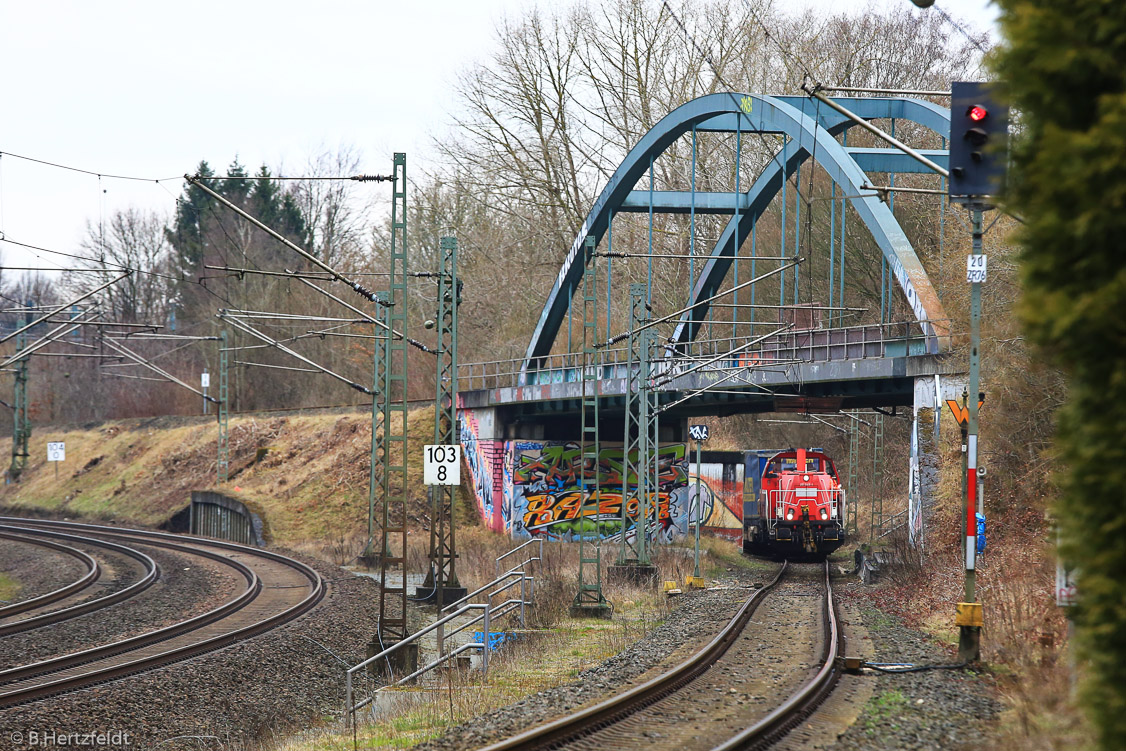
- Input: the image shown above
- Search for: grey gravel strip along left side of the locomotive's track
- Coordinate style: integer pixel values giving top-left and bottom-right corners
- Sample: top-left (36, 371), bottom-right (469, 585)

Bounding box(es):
top-left (415, 569), bottom-right (776, 751)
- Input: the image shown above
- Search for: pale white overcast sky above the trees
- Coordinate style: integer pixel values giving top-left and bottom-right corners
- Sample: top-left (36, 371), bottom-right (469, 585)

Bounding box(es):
top-left (0, 0), bottom-right (997, 273)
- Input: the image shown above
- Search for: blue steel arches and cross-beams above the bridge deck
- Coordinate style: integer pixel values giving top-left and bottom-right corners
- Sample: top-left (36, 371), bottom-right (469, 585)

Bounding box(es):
top-left (521, 93), bottom-right (950, 373)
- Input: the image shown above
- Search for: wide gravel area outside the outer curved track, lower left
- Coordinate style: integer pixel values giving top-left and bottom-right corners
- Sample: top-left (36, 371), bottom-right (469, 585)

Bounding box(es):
top-left (0, 551), bottom-right (387, 751)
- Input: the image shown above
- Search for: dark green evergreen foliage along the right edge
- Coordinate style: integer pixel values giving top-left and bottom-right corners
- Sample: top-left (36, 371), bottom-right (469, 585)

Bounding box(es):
top-left (998, 0), bottom-right (1126, 751)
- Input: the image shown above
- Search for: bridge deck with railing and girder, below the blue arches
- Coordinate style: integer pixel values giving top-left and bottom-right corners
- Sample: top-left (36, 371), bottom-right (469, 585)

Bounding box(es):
top-left (458, 323), bottom-right (962, 419)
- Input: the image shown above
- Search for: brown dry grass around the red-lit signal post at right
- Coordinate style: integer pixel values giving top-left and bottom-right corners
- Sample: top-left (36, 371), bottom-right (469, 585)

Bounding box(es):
top-left (875, 472), bottom-right (1091, 751)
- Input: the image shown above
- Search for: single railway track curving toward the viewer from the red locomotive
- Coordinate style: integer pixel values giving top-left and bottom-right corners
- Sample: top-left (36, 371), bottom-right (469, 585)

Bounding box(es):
top-left (483, 564), bottom-right (841, 751)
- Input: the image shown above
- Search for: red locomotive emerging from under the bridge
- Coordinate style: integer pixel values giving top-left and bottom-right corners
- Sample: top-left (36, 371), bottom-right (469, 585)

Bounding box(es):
top-left (743, 448), bottom-right (845, 557)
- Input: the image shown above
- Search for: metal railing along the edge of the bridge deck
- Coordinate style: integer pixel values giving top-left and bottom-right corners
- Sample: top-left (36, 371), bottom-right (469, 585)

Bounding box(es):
top-left (457, 321), bottom-right (949, 391)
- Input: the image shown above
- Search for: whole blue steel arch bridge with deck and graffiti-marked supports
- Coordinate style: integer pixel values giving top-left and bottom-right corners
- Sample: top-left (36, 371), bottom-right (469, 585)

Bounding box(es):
top-left (458, 93), bottom-right (962, 551)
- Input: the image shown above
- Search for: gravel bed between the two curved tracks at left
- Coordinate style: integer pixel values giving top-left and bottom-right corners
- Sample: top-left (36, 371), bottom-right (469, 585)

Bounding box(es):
top-left (0, 543), bottom-right (237, 669)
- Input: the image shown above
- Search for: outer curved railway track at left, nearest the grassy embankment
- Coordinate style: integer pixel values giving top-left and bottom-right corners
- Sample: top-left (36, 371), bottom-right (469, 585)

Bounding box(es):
top-left (0, 517), bottom-right (325, 708)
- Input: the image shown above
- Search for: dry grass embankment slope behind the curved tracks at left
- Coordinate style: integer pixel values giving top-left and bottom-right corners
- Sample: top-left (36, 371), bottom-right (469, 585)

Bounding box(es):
top-left (0, 409), bottom-right (441, 551)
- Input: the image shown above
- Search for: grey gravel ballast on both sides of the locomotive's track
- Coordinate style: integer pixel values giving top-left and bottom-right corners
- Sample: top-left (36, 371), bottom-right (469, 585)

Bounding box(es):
top-left (415, 562), bottom-right (1001, 751)
